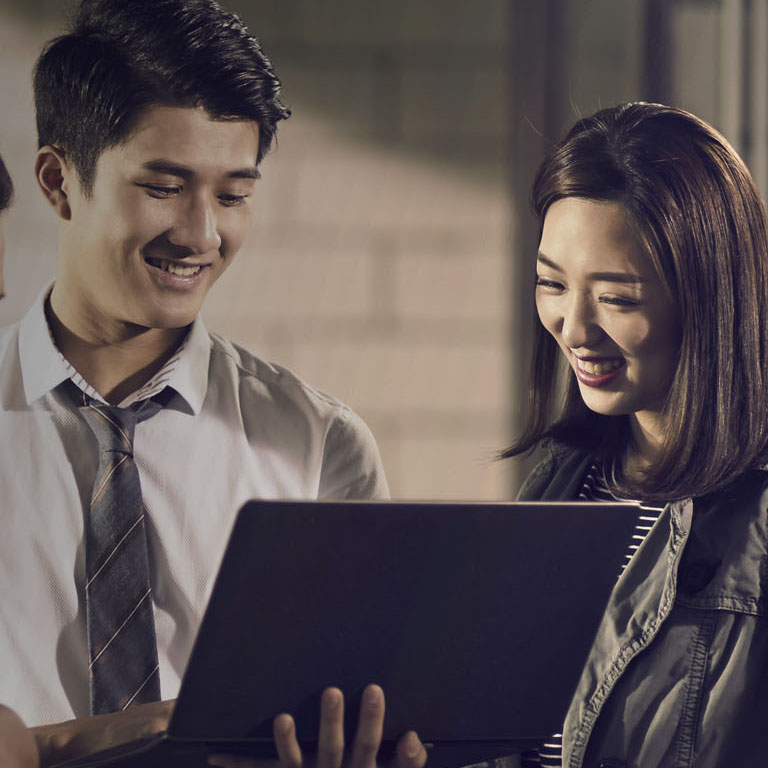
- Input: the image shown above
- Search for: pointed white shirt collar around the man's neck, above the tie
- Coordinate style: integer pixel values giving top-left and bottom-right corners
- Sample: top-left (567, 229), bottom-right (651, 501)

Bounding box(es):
top-left (19, 283), bottom-right (211, 414)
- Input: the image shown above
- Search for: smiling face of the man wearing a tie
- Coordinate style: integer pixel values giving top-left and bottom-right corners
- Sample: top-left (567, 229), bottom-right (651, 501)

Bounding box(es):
top-left (51, 106), bottom-right (258, 337)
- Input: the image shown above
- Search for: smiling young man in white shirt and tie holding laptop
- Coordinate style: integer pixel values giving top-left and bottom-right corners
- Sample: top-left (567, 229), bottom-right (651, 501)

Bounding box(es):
top-left (0, 0), bottom-right (423, 766)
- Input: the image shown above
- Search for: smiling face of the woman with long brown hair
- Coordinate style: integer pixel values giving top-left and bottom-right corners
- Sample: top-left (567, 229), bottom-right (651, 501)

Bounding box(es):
top-left (536, 197), bottom-right (680, 432)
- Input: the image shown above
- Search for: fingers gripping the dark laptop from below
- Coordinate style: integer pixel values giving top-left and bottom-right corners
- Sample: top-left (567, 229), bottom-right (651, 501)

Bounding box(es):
top-left (208, 685), bottom-right (427, 768)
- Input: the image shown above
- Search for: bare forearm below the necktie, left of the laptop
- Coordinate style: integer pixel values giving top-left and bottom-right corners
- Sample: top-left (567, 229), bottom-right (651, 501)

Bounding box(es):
top-left (31, 701), bottom-right (175, 768)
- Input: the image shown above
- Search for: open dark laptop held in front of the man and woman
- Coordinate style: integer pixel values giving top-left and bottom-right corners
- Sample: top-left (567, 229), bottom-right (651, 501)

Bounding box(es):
top-left (55, 500), bottom-right (640, 768)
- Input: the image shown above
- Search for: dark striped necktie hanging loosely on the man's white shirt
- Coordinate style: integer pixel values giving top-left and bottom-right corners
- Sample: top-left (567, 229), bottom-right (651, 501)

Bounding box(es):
top-left (81, 401), bottom-right (160, 715)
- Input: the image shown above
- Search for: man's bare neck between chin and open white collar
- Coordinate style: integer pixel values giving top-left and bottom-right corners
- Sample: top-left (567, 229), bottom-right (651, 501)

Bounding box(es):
top-left (45, 299), bottom-right (189, 405)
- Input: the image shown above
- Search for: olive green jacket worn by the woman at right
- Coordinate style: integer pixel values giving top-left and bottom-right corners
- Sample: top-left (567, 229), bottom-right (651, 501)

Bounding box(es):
top-left (519, 444), bottom-right (768, 768)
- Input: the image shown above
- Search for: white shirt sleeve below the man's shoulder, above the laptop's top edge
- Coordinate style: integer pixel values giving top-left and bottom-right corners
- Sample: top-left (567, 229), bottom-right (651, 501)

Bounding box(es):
top-left (318, 406), bottom-right (389, 500)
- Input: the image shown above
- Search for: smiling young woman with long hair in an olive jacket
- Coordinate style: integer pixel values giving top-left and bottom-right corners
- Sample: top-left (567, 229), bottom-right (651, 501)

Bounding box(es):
top-left (506, 104), bottom-right (768, 768)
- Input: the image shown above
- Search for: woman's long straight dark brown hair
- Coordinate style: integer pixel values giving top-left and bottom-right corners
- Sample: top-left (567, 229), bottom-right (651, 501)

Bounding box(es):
top-left (503, 103), bottom-right (768, 500)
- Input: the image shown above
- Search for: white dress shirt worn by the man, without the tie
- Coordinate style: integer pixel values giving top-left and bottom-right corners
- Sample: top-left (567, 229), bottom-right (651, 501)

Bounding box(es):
top-left (0, 292), bottom-right (387, 725)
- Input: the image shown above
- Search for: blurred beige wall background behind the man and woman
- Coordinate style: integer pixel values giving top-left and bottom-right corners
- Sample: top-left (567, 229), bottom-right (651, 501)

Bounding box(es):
top-left (0, 0), bottom-right (768, 499)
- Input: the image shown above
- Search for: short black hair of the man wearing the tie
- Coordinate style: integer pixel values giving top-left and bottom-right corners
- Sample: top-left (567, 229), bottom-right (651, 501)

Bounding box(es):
top-left (34, 0), bottom-right (290, 193)
